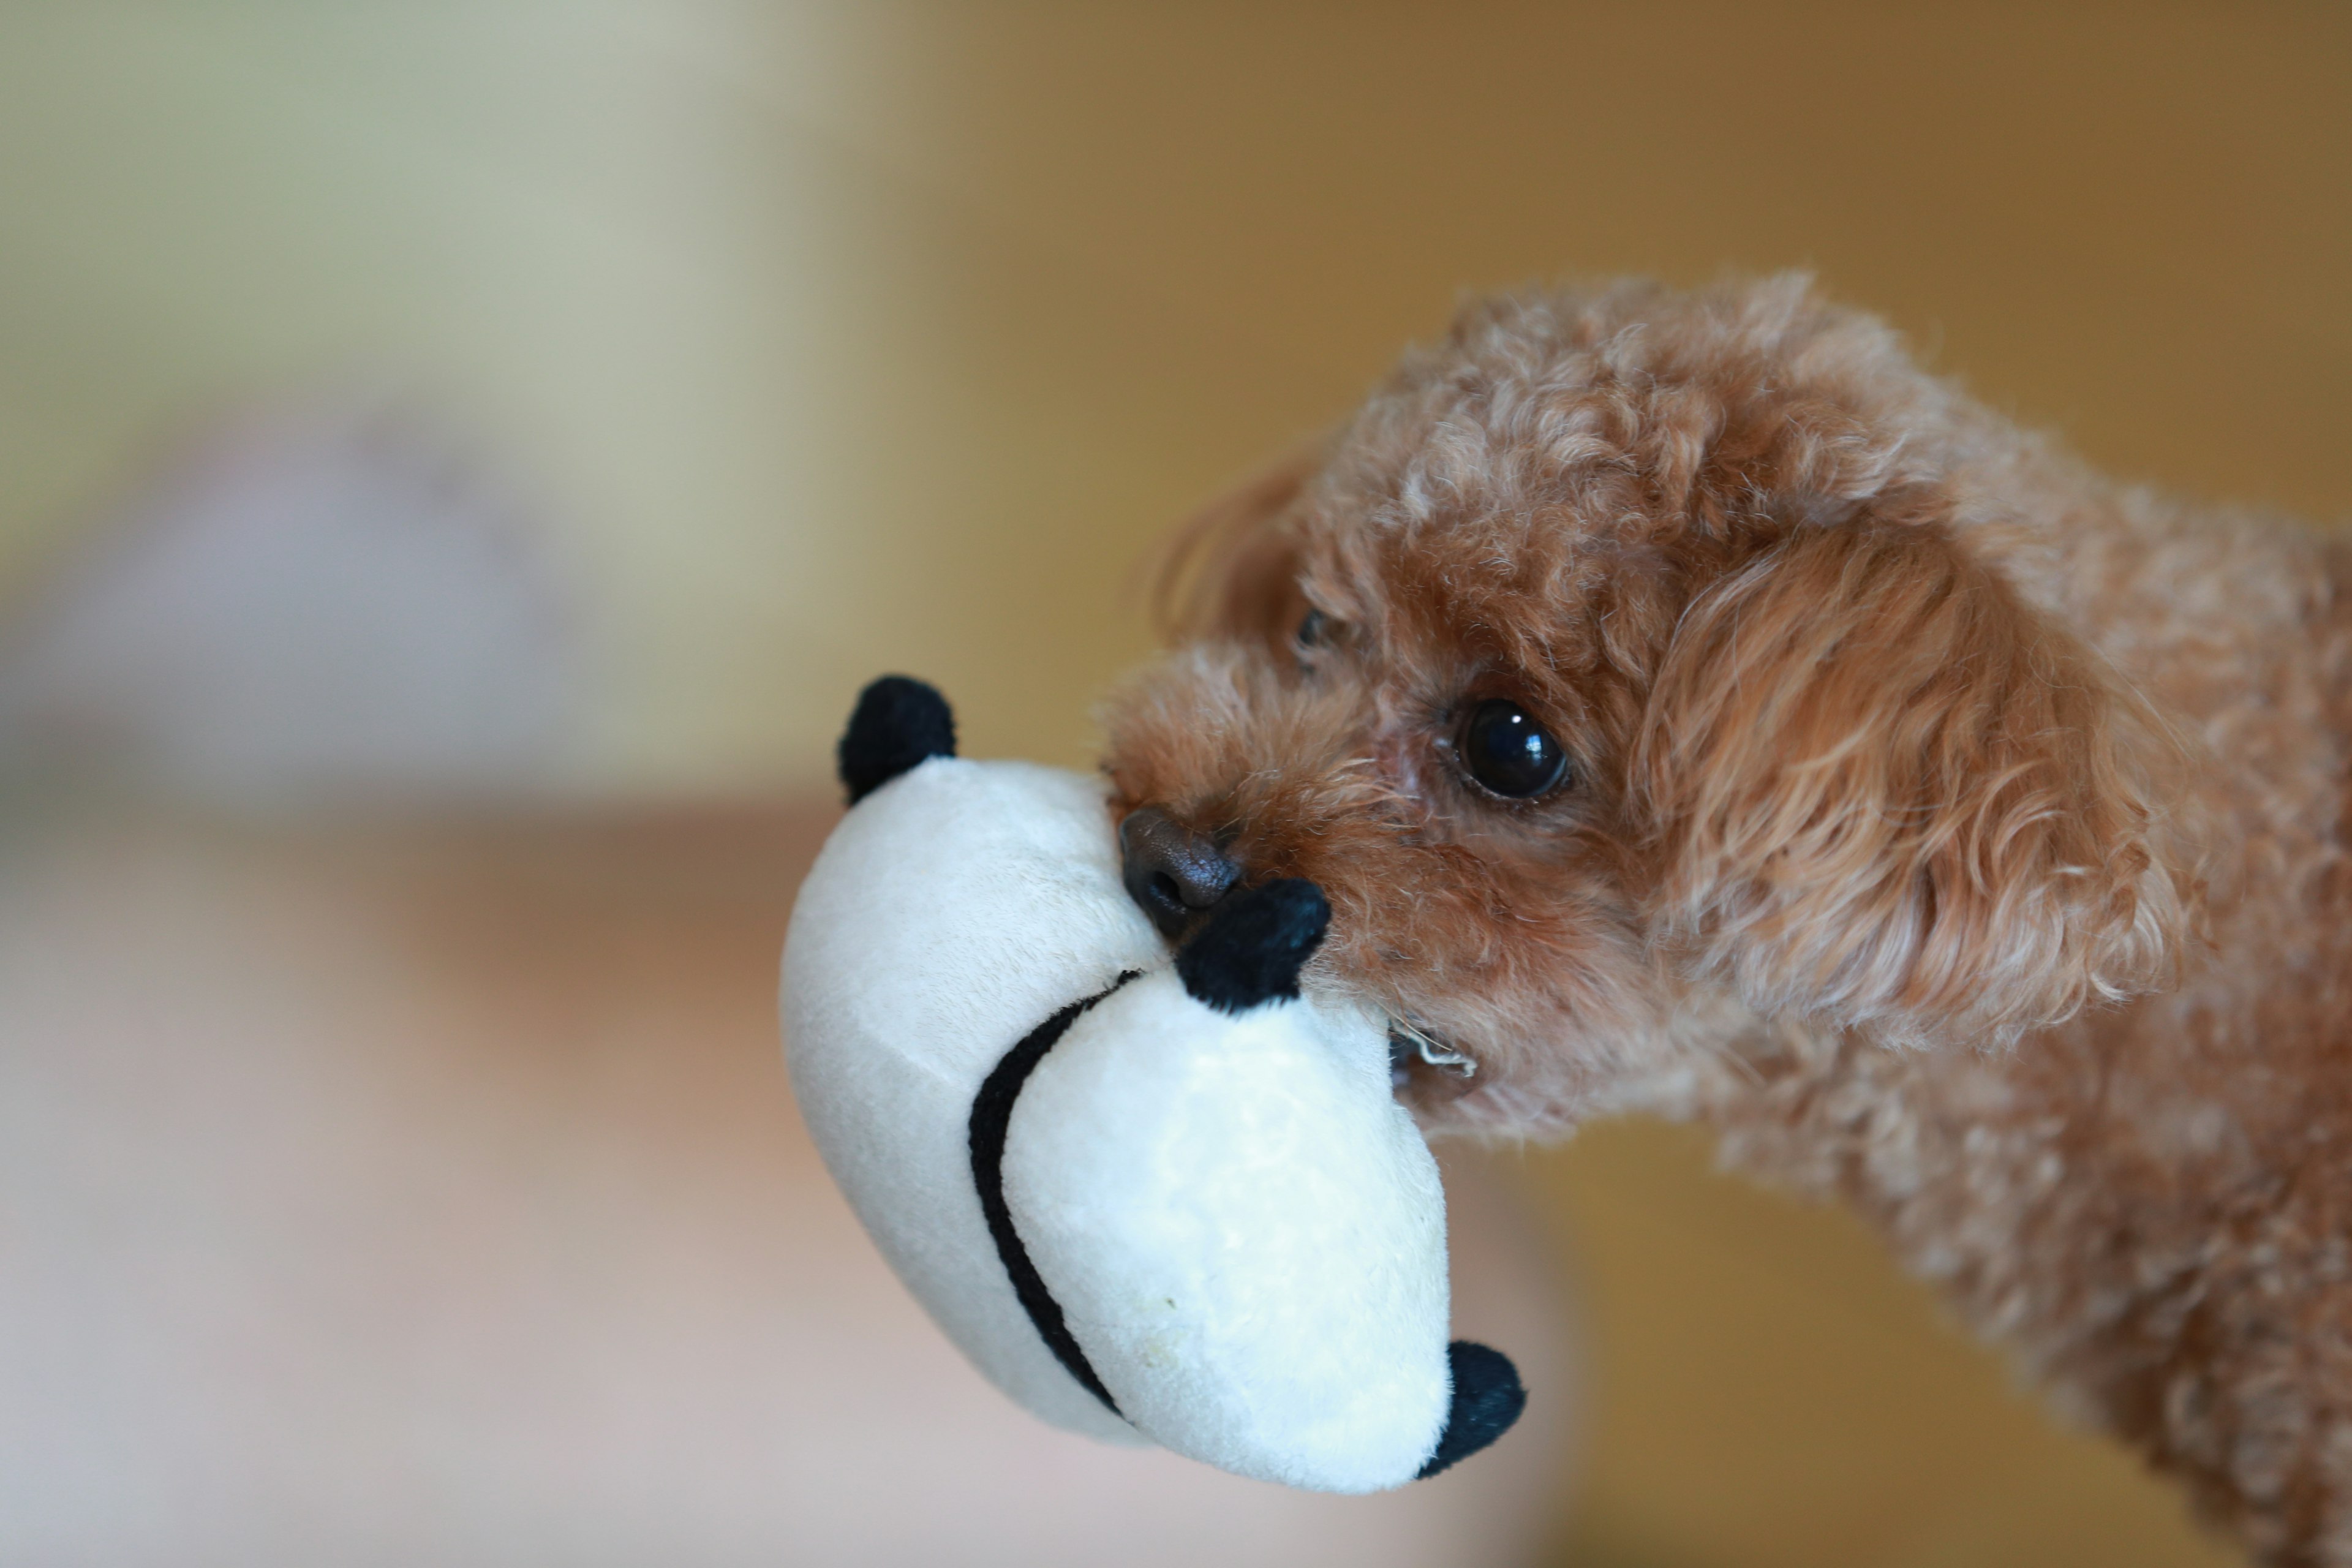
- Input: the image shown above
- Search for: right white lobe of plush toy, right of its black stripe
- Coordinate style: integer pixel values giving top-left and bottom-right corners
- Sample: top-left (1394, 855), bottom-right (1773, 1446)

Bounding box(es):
top-left (1005, 968), bottom-right (1451, 1493)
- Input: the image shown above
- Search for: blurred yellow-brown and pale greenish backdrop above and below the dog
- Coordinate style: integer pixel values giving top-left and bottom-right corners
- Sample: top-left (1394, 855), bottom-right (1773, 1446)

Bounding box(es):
top-left (0, 0), bottom-right (2352, 1568)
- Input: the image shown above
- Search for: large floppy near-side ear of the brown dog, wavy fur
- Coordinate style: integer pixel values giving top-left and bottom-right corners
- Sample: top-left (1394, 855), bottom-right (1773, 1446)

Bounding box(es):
top-left (1630, 519), bottom-right (2199, 1044)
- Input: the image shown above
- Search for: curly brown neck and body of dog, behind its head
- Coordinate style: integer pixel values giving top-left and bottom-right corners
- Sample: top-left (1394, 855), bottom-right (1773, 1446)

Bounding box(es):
top-left (1613, 500), bottom-right (2352, 1561)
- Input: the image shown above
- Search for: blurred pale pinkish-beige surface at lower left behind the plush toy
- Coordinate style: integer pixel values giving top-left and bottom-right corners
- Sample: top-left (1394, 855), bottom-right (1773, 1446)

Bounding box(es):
top-left (0, 804), bottom-right (1578, 1568)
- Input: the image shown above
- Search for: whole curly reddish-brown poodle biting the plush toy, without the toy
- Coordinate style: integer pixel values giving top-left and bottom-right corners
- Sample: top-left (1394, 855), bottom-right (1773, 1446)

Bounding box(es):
top-left (1108, 280), bottom-right (2352, 1563)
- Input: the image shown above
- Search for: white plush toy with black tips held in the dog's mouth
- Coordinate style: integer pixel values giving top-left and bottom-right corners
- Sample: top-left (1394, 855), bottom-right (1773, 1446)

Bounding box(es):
top-left (783, 677), bottom-right (1526, 1493)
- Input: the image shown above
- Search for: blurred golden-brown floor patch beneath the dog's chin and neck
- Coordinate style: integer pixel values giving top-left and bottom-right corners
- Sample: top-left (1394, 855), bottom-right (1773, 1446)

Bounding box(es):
top-left (1517, 1124), bottom-right (2242, 1568)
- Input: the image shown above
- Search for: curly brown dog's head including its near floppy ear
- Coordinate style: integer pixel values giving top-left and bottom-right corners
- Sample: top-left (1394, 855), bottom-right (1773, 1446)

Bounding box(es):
top-left (1106, 280), bottom-right (2195, 1131)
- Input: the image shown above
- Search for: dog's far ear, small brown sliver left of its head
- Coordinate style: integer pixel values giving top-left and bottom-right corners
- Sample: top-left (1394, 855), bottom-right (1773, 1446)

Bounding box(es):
top-left (1153, 437), bottom-right (1329, 649)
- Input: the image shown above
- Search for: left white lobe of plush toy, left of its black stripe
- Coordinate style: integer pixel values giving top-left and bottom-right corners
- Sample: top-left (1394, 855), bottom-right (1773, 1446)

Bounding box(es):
top-left (783, 757), bottom-right (1167, 1441)
